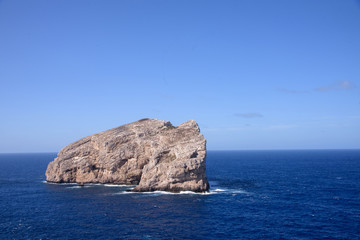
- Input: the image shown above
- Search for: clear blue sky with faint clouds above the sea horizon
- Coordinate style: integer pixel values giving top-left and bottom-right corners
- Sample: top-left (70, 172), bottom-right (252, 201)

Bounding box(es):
top-left (0, 0), bottom-right (360, 153)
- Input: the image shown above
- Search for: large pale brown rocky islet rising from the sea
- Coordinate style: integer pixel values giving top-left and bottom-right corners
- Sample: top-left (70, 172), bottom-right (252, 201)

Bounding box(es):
top-left (46, 119), bottom-right (209, 192)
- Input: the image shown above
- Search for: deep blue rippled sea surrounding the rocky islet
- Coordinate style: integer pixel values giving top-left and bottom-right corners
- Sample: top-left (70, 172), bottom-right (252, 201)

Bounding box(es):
top-left (0, 150), bottom-right (360, 239)
